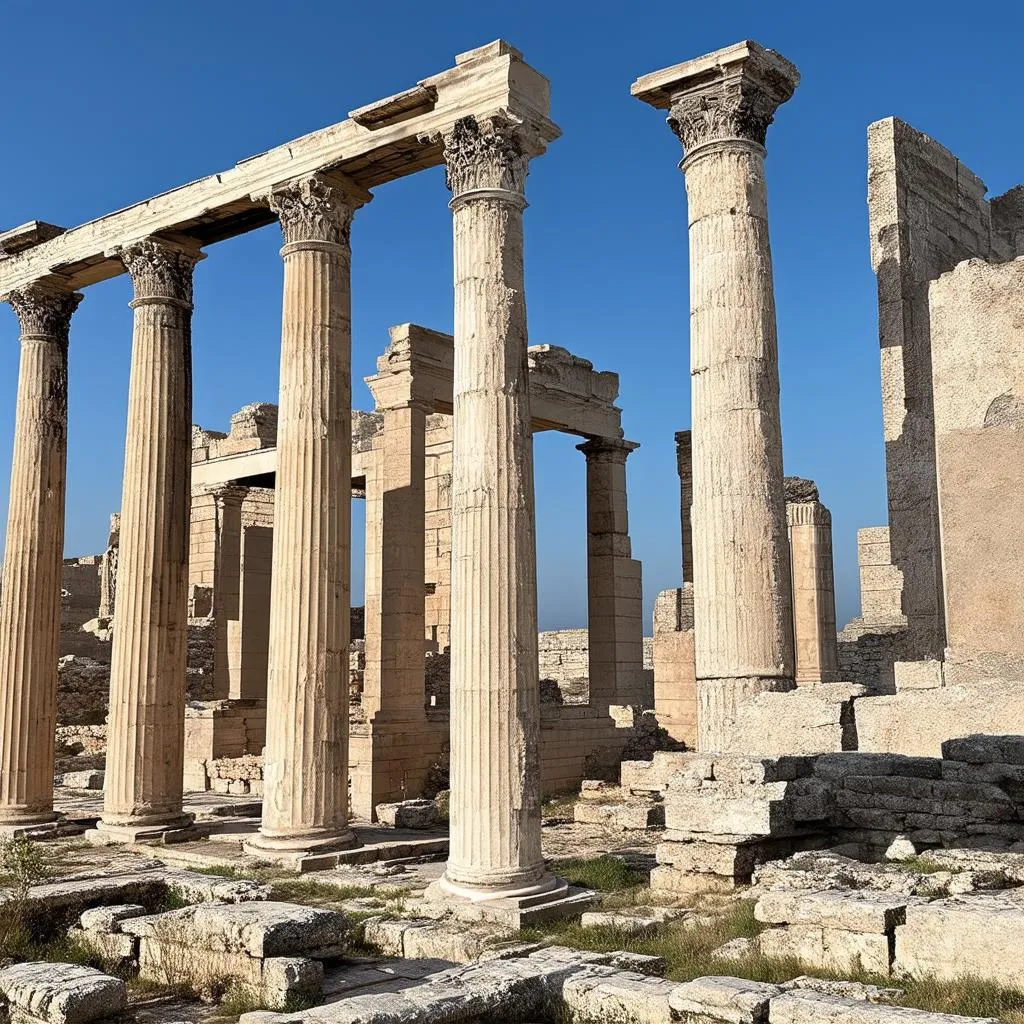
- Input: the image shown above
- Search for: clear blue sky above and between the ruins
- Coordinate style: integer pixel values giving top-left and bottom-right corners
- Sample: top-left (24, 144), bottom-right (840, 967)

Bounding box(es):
top-left (0, 0), bottom-right (1024, 629)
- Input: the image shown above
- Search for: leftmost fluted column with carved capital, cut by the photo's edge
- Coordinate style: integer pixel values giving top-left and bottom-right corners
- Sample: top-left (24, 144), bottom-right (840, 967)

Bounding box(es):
top-left (0, 284), bottom-right (82, 826)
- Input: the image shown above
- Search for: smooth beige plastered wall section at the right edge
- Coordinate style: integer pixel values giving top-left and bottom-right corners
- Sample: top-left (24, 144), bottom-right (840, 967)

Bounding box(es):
top-left (929, 259), bottom-right (1024, 685)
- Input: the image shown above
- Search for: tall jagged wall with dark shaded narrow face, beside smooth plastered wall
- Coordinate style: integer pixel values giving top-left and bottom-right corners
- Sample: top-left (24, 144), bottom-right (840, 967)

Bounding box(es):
top-left (867, 118), bottom-right (1021, 657)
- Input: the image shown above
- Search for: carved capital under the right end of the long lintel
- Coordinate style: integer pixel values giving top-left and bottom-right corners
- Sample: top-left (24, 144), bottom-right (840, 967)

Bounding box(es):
top-left (432, 117), bottom-right (536, 199)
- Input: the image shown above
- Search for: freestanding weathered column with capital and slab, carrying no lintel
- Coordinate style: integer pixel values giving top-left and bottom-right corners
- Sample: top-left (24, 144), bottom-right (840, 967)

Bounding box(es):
top-left (633, 42), bottom-right (799, 750)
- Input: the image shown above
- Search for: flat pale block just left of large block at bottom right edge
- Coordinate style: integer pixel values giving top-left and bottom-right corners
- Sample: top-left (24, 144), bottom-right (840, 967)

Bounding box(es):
top-left (754, 891), bottom-right (908, 935)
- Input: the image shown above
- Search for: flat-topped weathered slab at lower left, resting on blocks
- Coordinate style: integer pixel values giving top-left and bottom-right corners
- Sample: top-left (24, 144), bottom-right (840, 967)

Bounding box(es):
top-left (121, 901), bottom-right (347, 958)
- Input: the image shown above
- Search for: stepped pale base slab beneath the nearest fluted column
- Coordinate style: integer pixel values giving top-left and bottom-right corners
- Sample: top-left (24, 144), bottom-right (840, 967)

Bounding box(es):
top-left (423, 874), bottom-right (597, 929)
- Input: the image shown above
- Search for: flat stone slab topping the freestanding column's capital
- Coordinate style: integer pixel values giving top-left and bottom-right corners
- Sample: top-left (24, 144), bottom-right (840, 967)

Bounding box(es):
top-left (630, 39), bottom-right (800, 110)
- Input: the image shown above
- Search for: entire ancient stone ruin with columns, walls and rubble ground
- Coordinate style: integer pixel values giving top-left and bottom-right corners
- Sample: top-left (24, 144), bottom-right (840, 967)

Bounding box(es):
top-left (0, 28), bottom-right (1024, 1024)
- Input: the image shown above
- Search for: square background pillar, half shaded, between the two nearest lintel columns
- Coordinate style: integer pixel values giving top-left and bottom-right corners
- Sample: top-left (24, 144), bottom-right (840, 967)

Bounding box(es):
top-left (362, 400), bottom-right (429, 724)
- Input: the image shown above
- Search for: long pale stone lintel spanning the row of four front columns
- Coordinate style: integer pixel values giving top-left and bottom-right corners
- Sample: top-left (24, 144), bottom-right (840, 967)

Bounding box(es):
top-left (0, 42), bottom-right (559, 295)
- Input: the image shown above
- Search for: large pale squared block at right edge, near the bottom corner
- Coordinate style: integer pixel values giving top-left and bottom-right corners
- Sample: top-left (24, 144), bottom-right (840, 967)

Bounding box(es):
top-left (896, 893), bottom-right (1024, 988)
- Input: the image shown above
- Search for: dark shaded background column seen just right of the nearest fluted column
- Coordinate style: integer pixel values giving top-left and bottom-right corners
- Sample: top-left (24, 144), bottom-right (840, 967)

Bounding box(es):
top-left (577, 437), bottom-right (654, 708)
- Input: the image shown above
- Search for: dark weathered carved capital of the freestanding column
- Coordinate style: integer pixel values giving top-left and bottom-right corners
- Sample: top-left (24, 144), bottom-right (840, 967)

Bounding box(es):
top-left (668, 51), bottom-right (800, 154)
